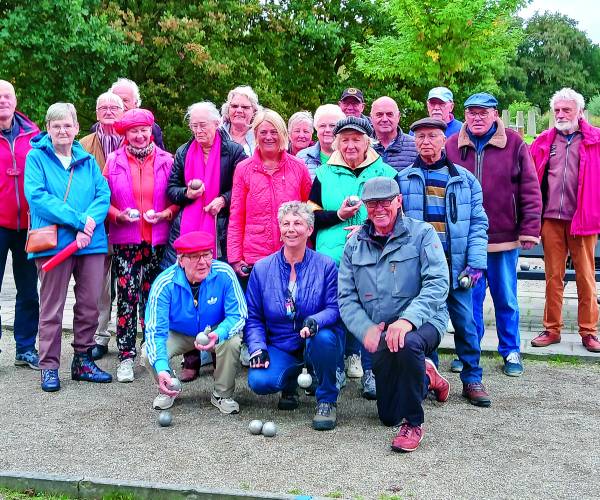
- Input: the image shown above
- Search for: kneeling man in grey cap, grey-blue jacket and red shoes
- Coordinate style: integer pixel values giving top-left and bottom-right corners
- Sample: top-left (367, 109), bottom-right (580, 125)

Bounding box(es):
top-left (338, 177), bottom-right (450, 452)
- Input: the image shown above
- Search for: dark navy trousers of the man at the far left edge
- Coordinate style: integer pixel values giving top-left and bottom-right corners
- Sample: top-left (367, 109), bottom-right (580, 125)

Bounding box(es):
top-left (0, 227), bottom-right (40, 354)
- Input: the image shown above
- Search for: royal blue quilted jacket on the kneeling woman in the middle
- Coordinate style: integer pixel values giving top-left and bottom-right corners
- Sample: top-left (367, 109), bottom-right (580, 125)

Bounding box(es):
top-left (244, 248), bottom-right (342, 353)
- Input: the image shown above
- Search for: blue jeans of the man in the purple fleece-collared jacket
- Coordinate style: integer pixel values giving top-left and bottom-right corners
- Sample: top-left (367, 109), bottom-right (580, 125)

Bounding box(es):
top-left (473, 248), bottom-right (521, 358)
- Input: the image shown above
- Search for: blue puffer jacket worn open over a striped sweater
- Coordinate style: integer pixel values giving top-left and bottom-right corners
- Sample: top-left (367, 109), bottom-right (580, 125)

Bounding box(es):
top-left (396, 160), bottom-right (488, 288)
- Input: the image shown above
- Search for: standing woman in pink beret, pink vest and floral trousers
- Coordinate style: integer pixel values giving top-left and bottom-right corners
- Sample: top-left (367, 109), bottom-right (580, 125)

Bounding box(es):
top-left (104, 108), bottom-right (179, 382)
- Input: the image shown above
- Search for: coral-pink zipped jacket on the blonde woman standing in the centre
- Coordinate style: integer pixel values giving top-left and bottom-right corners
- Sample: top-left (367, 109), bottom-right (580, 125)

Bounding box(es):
top-left (227, 149), bottom-right (311, 264)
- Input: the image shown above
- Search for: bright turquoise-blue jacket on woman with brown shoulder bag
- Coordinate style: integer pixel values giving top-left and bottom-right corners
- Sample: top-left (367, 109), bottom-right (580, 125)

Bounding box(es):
top-left (25, 132), bottom-right (110, 259)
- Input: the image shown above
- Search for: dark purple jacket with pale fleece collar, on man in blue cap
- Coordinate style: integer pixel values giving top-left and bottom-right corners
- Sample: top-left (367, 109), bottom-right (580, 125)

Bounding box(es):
top-left (446, 119), bottom-right (542, 252)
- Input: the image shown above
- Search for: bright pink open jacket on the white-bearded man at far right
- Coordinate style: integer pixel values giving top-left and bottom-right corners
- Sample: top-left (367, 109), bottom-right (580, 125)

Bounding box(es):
top-left (531, 119), bottom-right (600, 236)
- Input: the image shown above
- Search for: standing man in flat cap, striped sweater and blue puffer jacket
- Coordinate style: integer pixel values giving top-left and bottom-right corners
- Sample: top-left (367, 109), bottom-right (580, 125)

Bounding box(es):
top-left (396, 118), bottom-right (491, 406)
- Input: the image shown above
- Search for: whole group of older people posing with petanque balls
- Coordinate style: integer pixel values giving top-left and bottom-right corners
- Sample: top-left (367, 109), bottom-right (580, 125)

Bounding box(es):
top-left (0, 78), bottom-right (600, 452)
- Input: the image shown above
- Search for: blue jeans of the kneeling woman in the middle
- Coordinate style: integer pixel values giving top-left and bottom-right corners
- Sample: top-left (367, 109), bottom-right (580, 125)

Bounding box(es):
top-left (248, 328), bottom-right (343, 403)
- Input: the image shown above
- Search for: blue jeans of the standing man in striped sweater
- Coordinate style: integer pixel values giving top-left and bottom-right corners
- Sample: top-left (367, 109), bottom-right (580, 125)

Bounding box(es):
top-left (446, 288), bottom-right (483, 384)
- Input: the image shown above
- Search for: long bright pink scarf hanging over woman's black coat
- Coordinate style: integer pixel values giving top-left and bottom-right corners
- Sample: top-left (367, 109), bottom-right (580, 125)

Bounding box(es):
top-left (179, 132), bottom-right (221, 252)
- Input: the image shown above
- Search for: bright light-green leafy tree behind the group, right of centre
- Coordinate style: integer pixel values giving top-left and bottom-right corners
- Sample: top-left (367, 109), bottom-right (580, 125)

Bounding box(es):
top-left (353, 0), bottom-right (525, 118)
